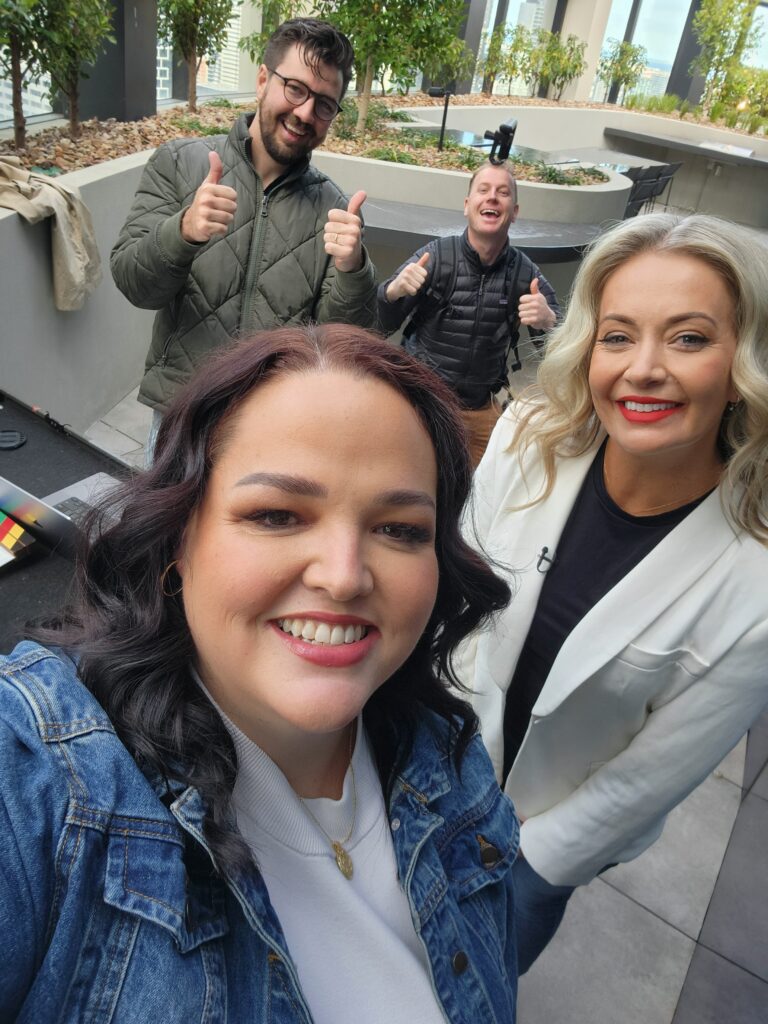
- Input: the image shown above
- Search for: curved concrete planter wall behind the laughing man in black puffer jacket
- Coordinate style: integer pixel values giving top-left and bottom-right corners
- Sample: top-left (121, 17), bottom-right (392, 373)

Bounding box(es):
top-left (312, 152), bottom-right (632, 224)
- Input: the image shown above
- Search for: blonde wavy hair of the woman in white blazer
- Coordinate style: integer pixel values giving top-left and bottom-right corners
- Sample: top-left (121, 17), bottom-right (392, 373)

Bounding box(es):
top-left (509, 213), bottom-right (768, 545)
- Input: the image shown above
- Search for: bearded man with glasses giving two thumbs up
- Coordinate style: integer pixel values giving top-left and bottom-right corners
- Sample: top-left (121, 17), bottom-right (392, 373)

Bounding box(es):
top-left (111, 17), bottom-right (376, 448)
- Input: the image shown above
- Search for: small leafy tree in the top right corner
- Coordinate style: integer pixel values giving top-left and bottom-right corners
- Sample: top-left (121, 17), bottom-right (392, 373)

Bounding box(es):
top-left (691, 0), bottom-right (760, 116)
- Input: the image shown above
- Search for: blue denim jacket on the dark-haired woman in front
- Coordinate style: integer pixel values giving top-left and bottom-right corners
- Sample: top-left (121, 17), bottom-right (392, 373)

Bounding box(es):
top-left (0, 643), bottom-right (518, 1024)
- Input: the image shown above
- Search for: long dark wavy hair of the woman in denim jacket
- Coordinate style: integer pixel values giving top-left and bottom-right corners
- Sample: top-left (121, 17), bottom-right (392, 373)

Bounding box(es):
top-left (47, 325), bottom-right (510, 867)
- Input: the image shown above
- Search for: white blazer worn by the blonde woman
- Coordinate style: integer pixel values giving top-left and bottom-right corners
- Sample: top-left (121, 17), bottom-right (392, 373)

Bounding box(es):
top-left (457, 411), bottom-right (768, 885)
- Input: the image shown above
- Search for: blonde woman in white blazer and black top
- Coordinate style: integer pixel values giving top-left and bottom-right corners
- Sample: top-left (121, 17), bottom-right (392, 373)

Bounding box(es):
top-left (460, 214), bottom-right (768, 972)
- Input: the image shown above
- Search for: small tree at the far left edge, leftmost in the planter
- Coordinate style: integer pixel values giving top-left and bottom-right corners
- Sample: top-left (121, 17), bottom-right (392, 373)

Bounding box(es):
top-left (0, 0), bottom-right (42, 150)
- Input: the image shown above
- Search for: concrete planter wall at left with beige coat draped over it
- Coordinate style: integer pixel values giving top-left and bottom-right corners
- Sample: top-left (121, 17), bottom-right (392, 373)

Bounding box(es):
top-left (0, 151), bottom-right (154, 431)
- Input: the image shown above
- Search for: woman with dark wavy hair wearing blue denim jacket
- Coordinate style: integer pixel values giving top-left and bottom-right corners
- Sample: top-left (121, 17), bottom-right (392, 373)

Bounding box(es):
top-left (0, 326), bottom-right (518, 1024)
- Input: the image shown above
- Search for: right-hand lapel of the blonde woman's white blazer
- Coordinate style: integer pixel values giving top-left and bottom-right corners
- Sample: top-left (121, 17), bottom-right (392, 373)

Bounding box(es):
top-left (534, 490), bottom-right (735, 716)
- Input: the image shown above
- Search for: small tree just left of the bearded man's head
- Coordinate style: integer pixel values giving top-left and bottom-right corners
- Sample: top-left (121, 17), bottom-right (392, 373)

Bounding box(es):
top-left (158, 0), bottom-right (239, 112)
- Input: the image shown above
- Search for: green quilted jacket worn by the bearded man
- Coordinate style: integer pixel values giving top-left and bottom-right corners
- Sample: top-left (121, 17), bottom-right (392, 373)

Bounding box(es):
top-left (111, 115), bottom-right (376, 410)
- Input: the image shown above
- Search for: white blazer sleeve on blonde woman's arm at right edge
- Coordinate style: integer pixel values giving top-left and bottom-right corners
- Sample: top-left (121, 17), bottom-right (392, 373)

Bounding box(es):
top-left (520, 620), bottom-right (768, 886)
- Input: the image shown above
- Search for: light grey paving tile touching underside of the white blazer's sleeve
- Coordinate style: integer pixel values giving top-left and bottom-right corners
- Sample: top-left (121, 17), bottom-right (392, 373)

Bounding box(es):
top-left (602, 775), bottom-right (741, 939)
